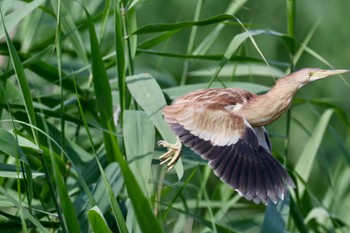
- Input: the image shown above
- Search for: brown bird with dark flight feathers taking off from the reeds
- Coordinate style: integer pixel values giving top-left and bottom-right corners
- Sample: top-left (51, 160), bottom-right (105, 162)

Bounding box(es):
top-left (158, 68), bottom-right (350, 205)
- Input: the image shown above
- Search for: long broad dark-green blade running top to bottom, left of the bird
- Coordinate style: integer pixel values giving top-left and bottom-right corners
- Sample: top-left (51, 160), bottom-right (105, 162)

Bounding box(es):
top-left (83, 7), bottom-right (162, 232)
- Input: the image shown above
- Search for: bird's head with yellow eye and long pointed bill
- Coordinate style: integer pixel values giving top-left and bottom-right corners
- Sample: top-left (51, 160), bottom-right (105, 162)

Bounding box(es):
top-left (289, 68), bottom-right (350, 87)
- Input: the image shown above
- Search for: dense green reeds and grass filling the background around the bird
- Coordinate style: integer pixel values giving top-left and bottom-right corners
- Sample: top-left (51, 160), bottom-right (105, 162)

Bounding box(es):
top-left (0, 0), bottom-right (350, 232)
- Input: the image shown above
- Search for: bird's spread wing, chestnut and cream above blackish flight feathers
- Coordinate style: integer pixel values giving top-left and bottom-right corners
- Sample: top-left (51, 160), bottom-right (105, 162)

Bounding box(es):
top-left (163, 89), bottom-right (295, 204)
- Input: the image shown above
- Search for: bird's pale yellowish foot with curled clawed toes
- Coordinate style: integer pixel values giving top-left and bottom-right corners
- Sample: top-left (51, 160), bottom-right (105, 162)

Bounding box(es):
top-left (157, 137), bottom-right (182, 172)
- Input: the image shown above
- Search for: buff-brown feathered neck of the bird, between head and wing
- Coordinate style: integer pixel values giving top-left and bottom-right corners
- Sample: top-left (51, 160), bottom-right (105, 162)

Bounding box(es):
top-left (244, 80), bottom-right (300, 126)
